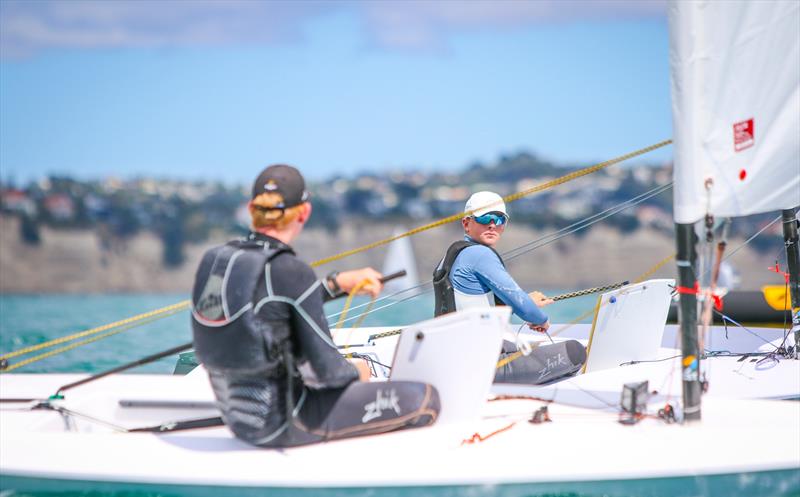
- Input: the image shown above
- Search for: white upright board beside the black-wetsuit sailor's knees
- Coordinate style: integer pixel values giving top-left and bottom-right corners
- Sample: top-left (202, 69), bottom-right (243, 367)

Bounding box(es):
top-left (389, 307), bottom-right (511, 424)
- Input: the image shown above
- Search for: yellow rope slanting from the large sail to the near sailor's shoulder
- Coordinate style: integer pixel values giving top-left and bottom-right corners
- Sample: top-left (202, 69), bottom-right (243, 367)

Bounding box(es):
top-left (311, 140), bottom-right (672, 267)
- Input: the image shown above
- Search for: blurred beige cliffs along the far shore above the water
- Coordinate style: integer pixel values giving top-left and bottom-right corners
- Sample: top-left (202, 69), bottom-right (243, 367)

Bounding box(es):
top-left (0, 216), bottom-right (783, 295)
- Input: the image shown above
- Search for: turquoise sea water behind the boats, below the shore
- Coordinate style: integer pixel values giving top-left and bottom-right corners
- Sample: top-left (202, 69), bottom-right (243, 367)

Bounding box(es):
top-left (0, 292), bottom-right (596, 373)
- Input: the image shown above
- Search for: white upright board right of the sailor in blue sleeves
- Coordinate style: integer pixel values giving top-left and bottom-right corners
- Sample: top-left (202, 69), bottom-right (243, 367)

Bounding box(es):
top-left (583, 279), bottom-right (675, 373)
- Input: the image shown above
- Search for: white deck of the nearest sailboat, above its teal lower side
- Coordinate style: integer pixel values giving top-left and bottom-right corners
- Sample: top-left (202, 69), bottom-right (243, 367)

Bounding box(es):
top-left (0, 375), bottom-right (800, 487)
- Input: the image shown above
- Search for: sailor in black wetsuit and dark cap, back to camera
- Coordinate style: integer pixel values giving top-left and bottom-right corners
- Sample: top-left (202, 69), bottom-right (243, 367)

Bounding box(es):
top-left (192, 165), bottom-right (439, 447)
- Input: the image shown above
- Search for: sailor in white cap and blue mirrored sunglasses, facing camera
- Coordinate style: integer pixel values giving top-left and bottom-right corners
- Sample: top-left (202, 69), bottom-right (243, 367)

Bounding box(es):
top-left (433, 191), bottom-right (586, 384)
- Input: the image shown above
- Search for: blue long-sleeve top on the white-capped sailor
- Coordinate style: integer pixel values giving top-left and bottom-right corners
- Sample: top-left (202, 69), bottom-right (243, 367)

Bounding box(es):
top-left (450, 236), bottom-right (547, 324)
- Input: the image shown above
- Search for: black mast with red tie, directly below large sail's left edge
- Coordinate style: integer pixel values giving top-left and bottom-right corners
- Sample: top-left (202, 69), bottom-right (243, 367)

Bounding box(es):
top-left (675, 223), bottom-right (702, 421)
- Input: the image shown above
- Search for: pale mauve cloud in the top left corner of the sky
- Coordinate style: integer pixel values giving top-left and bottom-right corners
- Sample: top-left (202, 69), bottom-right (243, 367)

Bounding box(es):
top-left (0, 0), bottom-right (333, 57)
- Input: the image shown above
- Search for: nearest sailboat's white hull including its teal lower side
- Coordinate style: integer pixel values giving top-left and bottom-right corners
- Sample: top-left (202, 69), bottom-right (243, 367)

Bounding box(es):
top-left (0, 346), bottom-right (800, 496)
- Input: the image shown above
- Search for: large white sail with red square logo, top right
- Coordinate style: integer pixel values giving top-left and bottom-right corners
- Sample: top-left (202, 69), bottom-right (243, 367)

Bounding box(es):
top-left (669, 0), bottom-right (800, 223)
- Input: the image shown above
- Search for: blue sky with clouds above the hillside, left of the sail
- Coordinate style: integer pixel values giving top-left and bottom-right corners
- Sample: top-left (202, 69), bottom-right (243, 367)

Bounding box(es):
top-left (0, 0), bottom-right (672, 183)
